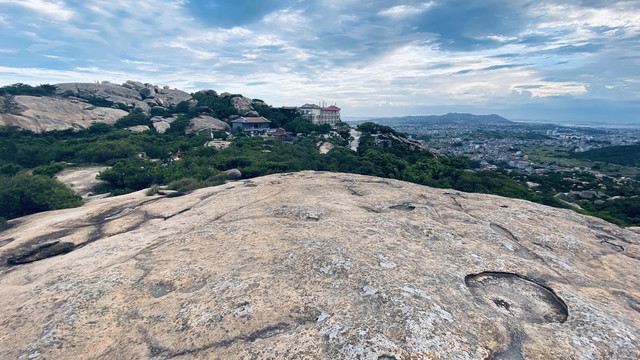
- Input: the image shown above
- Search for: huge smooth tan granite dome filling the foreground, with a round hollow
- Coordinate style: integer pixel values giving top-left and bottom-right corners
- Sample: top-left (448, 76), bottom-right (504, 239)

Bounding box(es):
top-left (0, 172), bottom-right (640, 359)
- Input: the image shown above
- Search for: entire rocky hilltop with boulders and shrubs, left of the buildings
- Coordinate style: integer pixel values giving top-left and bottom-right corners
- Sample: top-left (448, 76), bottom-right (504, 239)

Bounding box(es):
top-left (0, 80), bottom-right (278, 133)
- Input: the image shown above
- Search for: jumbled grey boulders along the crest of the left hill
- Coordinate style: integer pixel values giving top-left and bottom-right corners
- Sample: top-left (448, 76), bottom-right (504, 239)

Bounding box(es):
top-left (56, 80), bottom-right (191, 113)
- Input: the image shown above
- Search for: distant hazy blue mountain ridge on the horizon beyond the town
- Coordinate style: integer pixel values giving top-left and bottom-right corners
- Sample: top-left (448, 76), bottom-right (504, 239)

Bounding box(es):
top-left (367, 113), bottom-right (514, 125)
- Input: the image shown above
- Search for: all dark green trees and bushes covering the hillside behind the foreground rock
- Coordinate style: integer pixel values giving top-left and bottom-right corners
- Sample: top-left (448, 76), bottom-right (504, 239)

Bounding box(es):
top-left (0, 84), bottom-right (640, 226)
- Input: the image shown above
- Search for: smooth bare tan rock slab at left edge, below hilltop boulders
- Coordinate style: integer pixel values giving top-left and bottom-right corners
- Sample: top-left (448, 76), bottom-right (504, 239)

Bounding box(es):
top-left (0, 95), bottom-right (128, 132)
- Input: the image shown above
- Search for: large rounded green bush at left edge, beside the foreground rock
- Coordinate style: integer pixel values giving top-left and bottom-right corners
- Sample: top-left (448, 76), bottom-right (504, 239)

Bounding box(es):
top-left (0, 174), bottom-right (82, 219)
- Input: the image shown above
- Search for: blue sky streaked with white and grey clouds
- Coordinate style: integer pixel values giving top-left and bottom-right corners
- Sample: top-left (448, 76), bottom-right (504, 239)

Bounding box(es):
top-left (0, 0), bottom-right (640, 124)
